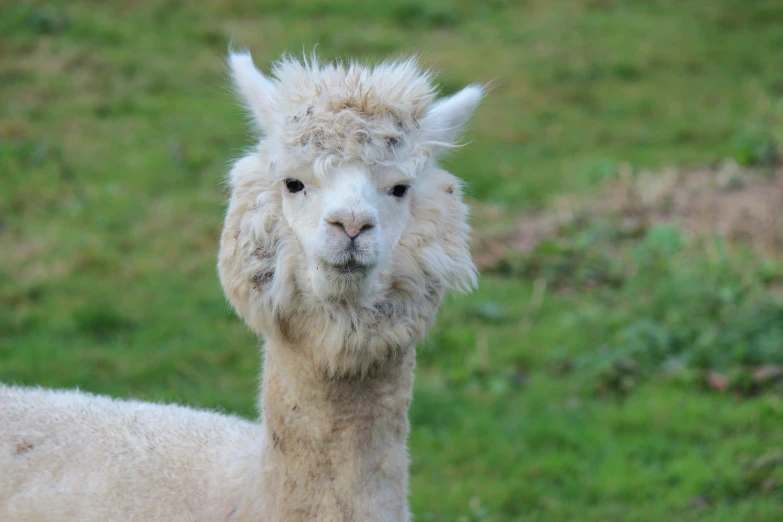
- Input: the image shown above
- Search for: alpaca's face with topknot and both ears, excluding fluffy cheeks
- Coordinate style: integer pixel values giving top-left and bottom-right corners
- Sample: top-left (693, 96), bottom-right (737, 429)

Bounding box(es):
top-left (224, 54), bottom-right (482, 299)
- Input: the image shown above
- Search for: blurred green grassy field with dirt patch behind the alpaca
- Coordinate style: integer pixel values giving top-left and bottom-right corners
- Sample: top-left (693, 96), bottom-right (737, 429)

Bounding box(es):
top-left (0, 0), bottom-right (783, 522)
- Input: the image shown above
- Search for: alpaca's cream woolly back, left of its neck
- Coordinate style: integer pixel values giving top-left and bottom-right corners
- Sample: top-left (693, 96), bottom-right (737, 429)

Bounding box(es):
top-left (0, 380), bottom-right (264, 522)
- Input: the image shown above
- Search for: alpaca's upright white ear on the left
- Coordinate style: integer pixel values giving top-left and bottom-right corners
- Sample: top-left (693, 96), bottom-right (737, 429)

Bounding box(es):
top-left (228, 52), bottom-right (277, 134)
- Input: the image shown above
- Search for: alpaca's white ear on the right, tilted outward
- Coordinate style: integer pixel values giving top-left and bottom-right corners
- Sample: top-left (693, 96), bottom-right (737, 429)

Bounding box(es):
top-left (421, 85), bottom-right (484, 154)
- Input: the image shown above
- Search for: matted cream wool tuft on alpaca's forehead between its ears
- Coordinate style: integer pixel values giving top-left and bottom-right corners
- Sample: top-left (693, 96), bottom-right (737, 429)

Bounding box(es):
top-left (272, 57), bottom-right (435, 164)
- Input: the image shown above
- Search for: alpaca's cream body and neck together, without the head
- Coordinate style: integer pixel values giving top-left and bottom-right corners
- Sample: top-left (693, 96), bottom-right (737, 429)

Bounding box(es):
top-left (0, 349), bottom-right (413, 522)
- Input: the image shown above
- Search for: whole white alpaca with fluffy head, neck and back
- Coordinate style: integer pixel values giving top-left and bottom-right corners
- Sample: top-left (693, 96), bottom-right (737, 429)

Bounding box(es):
top-left (0, 49), bottom-right (482, 522)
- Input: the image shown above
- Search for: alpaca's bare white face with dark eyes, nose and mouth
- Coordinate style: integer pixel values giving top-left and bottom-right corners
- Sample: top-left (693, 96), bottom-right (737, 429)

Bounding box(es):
top-left (280, 162), bottom-right (414, 299)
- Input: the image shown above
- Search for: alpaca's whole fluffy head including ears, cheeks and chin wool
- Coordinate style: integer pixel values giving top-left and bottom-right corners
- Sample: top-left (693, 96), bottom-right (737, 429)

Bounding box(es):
top-left (220, 54), bottom-right (482, 374)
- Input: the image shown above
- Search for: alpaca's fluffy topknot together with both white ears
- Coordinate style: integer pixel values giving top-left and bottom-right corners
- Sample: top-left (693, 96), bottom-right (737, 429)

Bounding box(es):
top-left (230, 53), bottom-right (482, 176)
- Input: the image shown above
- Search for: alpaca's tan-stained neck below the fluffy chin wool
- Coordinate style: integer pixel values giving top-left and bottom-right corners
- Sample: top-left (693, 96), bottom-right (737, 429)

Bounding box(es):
top-left (261, 343), bottom-right (415, 522)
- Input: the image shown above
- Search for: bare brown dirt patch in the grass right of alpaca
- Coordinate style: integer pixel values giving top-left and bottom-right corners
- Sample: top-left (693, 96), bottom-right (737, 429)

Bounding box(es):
top-left (473, 161), bottom-right (783, 270)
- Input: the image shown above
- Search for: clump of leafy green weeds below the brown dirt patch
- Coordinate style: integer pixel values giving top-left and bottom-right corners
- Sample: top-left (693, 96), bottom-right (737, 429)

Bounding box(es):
top-left (490, 214), bottom-right (783, 395)
